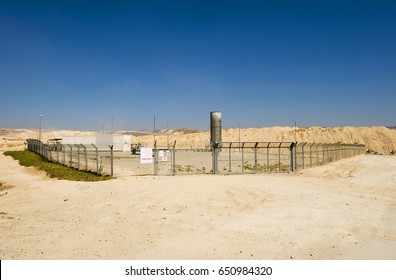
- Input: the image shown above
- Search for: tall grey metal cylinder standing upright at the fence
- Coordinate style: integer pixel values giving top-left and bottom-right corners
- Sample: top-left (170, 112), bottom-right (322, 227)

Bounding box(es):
top-left (210, 112), bottom-right (221, 174)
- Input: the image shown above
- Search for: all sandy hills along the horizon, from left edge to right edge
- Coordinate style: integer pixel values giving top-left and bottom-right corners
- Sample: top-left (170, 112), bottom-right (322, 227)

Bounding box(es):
top-left (0, 126), bottom-right (396, 154)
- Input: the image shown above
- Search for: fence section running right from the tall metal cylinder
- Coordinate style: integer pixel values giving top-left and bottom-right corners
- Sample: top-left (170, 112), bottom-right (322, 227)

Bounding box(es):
top-left (214, 142), bottom-right (365, 173)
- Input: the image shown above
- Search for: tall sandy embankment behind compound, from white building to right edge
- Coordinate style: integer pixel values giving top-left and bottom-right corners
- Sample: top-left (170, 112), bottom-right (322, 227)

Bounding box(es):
top-left (133, 126), bottom-right (396, 154)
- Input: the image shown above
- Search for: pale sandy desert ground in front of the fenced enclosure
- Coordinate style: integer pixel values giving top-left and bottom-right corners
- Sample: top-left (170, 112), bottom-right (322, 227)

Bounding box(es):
top-left (0, 151), bottom-right (396, 260)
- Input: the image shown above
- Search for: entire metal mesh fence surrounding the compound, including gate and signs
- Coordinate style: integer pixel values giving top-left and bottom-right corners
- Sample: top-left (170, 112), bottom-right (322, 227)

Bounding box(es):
top-left (27, 139), bottom-right (365, 176)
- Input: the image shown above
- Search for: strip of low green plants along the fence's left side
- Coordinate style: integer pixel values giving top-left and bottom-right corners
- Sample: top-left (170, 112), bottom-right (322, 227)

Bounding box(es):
top-left (4, 151), bottom-right (111, 182)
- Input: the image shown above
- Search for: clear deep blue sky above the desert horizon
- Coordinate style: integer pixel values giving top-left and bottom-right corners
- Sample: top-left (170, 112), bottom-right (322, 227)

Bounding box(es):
top-left (0, 0), bottom-right (396, 130)
